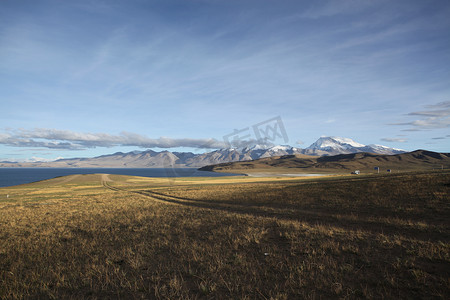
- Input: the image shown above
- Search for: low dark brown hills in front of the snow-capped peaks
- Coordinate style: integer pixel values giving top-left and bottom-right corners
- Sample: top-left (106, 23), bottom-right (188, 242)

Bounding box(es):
top-left (200, 150), bottom-right (450, 173)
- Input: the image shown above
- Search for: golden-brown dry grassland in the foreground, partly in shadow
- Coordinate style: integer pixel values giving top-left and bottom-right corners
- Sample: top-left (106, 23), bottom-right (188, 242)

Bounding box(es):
top-left (0, 171), bottom-right (450, 299)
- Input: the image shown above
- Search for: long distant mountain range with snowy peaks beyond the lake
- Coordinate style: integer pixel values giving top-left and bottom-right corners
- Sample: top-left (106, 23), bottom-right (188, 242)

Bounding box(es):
top-left (0, 137), bottom-right (405, 168)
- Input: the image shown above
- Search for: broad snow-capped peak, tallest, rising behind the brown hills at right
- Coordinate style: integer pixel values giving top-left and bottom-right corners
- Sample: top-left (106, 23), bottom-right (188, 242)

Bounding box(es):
top-left (303, 136), bottom-right (406, 155)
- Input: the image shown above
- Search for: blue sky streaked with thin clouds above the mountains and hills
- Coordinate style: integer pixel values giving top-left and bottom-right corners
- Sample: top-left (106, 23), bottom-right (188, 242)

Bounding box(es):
top-left (0, 0), bottom-right (450, 161)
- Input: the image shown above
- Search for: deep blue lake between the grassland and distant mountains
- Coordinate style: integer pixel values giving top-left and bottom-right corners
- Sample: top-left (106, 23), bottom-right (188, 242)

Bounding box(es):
top-left (0, 168), bottom-right (241, 187)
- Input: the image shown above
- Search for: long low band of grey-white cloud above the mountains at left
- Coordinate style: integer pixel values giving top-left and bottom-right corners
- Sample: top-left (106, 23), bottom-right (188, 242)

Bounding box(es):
top-left (0, 128), bottom-right (225, 150)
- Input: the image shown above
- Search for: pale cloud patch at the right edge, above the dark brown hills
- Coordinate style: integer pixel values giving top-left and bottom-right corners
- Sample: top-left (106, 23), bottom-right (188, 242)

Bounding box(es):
top-left (390, 101), bottom-right (450, 131)
